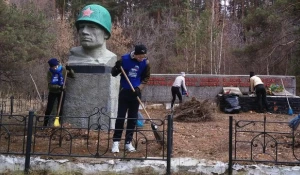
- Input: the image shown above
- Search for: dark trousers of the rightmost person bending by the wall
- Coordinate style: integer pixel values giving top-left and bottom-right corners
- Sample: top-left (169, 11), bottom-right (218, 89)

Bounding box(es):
top-left (255, 84), bottom-right (269, 112)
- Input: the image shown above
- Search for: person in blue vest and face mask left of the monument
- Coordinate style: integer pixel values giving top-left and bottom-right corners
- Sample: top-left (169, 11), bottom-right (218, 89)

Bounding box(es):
top-left (43, 58), bottom-right (74, 127)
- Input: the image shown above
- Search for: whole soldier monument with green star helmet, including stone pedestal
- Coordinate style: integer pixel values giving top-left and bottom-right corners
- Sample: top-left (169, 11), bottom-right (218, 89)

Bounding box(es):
top-left (63, 4), bottom-right (119, 129)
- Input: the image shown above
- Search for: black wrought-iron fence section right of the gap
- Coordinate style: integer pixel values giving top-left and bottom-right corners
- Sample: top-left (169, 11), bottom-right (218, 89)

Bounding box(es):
top-left (228, 116), bottom-right (300, 174)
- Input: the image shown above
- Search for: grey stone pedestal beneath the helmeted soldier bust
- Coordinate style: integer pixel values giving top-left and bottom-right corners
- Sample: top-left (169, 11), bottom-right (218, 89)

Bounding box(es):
top-left (63, 65), bottom-right (120, 130)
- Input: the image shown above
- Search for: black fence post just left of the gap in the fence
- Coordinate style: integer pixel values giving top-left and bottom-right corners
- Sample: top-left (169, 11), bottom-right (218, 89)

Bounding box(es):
top-left (166, 114), bottom-right (173, 175)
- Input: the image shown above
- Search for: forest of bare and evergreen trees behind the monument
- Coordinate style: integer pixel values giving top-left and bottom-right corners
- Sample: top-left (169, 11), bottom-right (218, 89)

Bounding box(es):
top-left (0, 0), bottom-right (300, 92)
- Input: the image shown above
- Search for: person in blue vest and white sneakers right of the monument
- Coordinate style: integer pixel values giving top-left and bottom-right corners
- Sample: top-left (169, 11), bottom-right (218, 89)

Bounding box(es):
top-left (111, 44), bottom-right (150, 153)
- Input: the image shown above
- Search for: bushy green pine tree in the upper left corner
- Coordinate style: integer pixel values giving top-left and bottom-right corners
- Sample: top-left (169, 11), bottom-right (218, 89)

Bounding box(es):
top-left (0, 0), bottom-right (55, 91)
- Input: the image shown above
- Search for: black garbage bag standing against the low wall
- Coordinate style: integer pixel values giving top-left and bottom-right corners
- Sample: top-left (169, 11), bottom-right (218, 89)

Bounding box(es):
top-left (224, 94), bottom-right (241, 114)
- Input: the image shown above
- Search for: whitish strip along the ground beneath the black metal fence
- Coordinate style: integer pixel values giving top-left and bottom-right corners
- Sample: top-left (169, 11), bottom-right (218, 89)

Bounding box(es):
top-left (0, 155), bottom-right (300, 175)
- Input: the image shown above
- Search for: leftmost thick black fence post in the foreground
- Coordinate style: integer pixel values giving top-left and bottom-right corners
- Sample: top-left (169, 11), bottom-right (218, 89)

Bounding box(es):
top-left (24, 110), bottom-right (34, 174)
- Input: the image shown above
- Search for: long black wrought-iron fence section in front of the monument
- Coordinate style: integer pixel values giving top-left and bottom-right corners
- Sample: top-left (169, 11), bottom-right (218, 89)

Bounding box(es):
top-left (0, 110), bottom-right (173, 174)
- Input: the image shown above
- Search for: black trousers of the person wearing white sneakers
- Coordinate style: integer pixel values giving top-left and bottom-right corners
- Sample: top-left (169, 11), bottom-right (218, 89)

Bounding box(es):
top-left (113, 89), bottom-right (139, 144)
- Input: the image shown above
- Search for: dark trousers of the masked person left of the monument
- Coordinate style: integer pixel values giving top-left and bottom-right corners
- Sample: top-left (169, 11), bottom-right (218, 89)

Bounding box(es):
top-left (43, 92), bottom-right (65, 126)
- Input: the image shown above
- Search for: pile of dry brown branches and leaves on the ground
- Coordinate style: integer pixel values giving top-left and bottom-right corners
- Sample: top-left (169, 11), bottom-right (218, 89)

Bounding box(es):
top-left (174, 97), bottom-right (215, 122)
